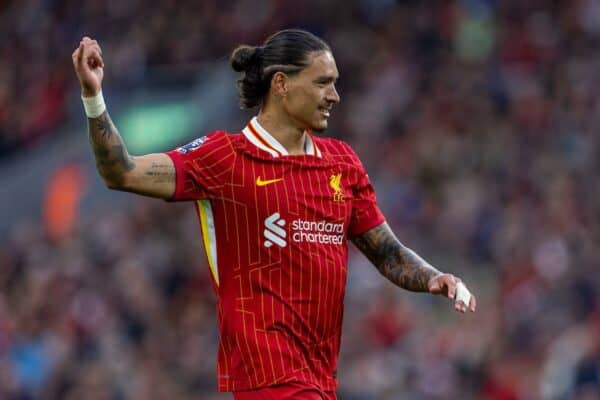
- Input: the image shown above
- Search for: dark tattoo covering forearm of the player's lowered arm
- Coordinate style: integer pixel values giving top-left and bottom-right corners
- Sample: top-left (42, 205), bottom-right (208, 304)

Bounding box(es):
top-left (352, 223), bottom-right (441, 292)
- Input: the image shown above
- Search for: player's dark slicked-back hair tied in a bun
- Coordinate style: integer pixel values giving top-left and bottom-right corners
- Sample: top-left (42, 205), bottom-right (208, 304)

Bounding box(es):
top-left (229, 29), bottom-right (331, 108)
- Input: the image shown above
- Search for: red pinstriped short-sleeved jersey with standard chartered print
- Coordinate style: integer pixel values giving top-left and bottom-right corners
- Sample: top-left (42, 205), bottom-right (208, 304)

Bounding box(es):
top-left (167, 117), bottom-right (384, 391)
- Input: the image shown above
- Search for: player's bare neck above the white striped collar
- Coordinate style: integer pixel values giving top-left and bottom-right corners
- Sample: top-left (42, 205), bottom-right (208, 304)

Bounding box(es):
top-left (258, 109), bottom-right (306, 155)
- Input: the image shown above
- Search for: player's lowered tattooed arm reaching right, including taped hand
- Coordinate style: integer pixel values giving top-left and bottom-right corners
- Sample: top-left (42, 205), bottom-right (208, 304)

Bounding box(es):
top-left (352, 223), bottom-right (477, 312)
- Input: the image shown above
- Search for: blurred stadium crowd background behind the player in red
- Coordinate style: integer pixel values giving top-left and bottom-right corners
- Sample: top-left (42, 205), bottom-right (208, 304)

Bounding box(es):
top-left (0, 0), bottom-right (600, 400)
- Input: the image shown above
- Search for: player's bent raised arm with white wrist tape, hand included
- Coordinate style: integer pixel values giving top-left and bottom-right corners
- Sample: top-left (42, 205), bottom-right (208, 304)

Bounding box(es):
top-left (72, 37), bottom-right (175, 198)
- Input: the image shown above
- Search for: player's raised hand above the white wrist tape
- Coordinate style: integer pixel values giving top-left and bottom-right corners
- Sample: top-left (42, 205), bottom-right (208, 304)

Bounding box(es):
top-left (72, 36), bottom-right (104, 97)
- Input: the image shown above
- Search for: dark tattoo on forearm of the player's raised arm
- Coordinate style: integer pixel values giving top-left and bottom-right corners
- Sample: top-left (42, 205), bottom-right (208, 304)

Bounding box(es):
top-left (88, 111), bottom-right (135, 185)
